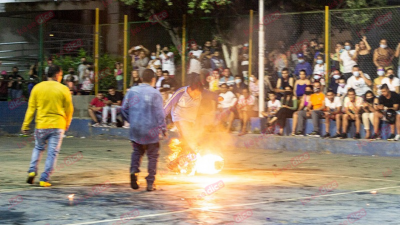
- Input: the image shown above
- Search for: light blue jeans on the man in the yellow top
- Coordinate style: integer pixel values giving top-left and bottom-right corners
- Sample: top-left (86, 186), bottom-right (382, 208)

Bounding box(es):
top-left (28, 129), bottom-right (65, 181)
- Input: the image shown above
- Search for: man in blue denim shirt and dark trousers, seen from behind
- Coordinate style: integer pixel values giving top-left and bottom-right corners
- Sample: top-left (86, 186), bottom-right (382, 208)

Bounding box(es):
top-left (122, 69), bottom-right (167, 191)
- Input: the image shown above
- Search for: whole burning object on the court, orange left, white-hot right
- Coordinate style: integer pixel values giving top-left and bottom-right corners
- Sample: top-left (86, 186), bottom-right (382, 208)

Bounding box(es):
top-left (167, 138), bottom-right (224, 175)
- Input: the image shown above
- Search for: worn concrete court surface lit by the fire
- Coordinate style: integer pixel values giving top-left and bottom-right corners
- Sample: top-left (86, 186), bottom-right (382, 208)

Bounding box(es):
top-left (0, 136), bottom-right (400, 225)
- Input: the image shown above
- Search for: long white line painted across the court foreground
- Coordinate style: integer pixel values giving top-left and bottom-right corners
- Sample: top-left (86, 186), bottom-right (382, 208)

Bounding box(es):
top-left (62, 186), bottom-right (400, 225)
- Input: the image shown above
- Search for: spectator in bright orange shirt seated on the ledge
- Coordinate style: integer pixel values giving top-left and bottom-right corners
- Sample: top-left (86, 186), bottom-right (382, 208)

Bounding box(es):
top-left (296, 82), bottom-right (325, 137)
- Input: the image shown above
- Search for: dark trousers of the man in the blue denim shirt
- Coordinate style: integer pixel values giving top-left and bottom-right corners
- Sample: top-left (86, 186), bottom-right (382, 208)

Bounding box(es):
top-left (130, 141), bottom-right (160, 184)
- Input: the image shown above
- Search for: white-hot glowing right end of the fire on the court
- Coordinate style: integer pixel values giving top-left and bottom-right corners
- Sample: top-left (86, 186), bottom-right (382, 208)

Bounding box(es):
top-left (196, 154), bottom-right (224, 174)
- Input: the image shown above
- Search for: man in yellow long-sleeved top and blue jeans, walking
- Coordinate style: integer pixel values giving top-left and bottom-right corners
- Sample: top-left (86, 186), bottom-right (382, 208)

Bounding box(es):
top-left (22, 65), bottom-right (74, 187)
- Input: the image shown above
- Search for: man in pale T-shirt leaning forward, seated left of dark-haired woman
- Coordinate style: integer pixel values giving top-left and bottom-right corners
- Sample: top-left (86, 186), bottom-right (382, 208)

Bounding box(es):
top-left (342, 88), bottom-right (363, 139)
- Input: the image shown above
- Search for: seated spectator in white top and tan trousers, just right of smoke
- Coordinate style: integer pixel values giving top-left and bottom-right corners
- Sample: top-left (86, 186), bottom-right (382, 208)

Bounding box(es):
top-left (217, 84), bottom-right (237, 132)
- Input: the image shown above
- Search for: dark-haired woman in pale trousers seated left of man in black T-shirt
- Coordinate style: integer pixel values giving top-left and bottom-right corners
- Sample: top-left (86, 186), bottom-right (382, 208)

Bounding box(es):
top-left (362, 91), bottom-right (378, 139)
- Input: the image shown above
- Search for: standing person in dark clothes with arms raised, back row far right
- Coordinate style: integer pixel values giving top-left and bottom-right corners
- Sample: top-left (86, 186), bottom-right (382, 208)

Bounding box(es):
top-left (354, 36), bottom-right (375, 79)
